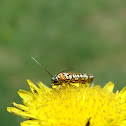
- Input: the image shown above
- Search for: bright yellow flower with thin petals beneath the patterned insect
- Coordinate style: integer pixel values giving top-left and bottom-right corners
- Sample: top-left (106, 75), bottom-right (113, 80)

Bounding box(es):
top-left (7, 80), bottom-right (126, 126)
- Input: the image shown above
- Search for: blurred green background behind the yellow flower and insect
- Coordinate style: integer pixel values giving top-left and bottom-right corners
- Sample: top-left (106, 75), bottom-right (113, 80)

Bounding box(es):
top-left (0, 0), bottom-right (126, 126)
